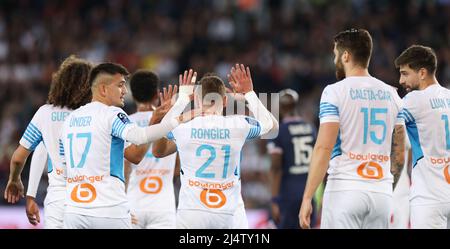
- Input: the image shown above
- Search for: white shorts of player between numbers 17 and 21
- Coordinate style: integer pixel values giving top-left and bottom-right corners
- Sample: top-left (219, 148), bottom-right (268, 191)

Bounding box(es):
top-left (132, 211), bottom-right (177, 229)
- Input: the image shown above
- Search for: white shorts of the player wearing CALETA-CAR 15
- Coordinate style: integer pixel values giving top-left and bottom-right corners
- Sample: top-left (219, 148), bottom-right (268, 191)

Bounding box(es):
top-left (320, 190), bottom-right (392, 229)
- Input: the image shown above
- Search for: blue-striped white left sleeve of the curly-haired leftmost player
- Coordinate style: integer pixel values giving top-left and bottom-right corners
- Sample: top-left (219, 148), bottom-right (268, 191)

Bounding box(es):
top-left (19, 108), bottom-right (42, 151)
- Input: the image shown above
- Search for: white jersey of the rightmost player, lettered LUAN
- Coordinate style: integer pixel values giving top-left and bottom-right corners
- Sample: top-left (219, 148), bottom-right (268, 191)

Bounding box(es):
top-left (402, 84), bottom-right (450, 205)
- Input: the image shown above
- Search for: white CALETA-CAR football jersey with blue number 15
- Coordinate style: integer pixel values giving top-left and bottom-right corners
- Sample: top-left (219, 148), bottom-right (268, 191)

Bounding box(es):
top-left (319, 77), bottom-right (403, 194)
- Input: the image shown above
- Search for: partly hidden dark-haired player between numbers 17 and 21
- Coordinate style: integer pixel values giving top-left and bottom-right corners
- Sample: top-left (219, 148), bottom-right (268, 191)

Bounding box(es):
top-left (125, 70), bottom-right (177, 229)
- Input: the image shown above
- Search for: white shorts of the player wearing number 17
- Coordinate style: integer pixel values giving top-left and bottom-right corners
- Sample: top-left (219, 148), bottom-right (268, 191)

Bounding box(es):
top-left (64, 213), bottom-right (131, 229)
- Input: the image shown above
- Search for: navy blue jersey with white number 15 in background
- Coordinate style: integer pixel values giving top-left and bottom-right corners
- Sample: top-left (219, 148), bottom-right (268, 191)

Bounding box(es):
top-left (268, 118), bottom-right (317, 201)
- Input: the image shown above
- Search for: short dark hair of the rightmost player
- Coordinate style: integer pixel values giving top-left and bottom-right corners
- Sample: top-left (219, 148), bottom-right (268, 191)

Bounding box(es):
top-left (394, 45), bottom-right (437, 74)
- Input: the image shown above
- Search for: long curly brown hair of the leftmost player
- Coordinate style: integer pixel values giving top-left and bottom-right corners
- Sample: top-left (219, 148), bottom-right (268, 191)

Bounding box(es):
top-left (47, 55), bottom-right (93, 109)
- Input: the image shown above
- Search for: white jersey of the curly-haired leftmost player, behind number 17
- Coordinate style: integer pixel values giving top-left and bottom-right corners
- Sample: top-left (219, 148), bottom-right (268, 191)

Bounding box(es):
top-left (19, 104), bottom-right (71, 203)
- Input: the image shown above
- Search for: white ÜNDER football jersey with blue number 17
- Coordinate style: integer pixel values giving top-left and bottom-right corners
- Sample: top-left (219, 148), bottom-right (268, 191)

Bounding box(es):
top-left (61, 102), bottom-right (136, 218)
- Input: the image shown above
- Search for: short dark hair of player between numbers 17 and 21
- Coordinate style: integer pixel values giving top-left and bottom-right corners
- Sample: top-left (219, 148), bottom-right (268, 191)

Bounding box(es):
top-left (130, 69), bottom-right (159, 103)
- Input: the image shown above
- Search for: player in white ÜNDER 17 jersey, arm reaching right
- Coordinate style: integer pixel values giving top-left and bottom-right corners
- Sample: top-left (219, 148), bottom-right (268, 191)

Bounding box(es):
top-left (61, 63), bottom-right (193, 228)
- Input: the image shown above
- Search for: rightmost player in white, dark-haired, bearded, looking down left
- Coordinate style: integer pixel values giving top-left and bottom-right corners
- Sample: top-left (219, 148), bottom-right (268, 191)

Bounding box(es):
top-left (395, 45), bottom-right (450, 229)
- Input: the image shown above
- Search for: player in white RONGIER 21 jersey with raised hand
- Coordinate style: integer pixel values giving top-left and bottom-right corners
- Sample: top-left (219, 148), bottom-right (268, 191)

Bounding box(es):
top-left (153, 65), bottom-right (278, 229)
